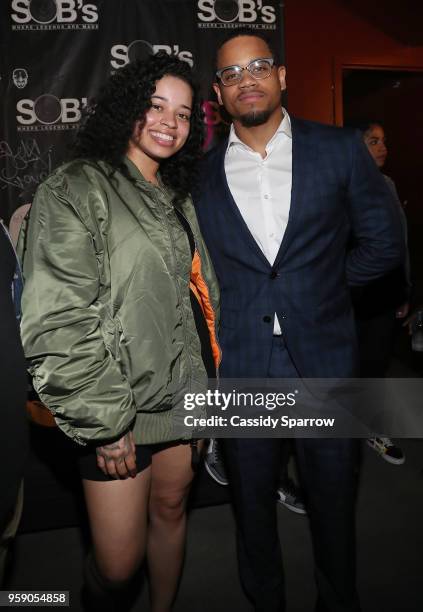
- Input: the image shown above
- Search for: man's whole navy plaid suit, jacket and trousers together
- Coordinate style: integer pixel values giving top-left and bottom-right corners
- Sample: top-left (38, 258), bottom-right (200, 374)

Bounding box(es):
top-left (195, 118), bottom-right (403, 612)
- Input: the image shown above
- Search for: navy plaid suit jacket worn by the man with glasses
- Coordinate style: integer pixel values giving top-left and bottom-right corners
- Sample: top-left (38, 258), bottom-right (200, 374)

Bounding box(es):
top-left (195, 118), bottom-right (404, 378)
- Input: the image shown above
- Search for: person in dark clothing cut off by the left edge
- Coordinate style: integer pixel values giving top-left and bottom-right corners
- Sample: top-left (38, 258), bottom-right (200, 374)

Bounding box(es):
top-left (0, 220), bottom-right (28, 585)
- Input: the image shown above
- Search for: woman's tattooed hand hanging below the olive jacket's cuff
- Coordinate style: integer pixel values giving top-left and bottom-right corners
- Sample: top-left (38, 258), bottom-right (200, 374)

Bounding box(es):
top-left (96, 431), bottom-right (137, 479)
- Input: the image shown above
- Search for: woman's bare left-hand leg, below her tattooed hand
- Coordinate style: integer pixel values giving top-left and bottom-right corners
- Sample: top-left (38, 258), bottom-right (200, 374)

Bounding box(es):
top-left (82, 466), bottom-right (151, 585)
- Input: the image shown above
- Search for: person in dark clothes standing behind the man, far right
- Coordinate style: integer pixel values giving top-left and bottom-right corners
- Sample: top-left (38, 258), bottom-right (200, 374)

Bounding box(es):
top-left (350, 120), bottom-right (411, 465)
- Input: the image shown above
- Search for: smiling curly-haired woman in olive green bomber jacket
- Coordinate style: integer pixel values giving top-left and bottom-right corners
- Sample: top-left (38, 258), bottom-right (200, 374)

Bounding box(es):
top-left (22, 54), bottom-right (220, 612)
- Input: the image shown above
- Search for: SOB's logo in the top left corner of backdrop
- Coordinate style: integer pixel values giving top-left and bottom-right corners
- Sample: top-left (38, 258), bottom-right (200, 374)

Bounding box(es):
top-left (11, 0), bottom-right (98, 30)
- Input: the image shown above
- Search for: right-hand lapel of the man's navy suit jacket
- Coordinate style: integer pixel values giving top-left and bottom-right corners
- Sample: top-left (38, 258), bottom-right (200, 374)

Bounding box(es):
top-left (273, 117), bottom-right (316, 267)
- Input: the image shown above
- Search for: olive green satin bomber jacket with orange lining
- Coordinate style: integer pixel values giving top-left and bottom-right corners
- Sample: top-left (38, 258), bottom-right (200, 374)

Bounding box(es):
top-left (21, 158), bottom-right (220, 444)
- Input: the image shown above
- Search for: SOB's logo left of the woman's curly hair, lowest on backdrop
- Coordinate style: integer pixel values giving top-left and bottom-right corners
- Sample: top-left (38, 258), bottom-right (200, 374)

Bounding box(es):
top-left (16, 94), bottom-right (87, 132)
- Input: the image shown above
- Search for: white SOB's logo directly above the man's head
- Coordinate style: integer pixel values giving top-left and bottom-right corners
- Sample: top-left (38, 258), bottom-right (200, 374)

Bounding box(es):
top-left (197, 0), bottom-right (276, 30)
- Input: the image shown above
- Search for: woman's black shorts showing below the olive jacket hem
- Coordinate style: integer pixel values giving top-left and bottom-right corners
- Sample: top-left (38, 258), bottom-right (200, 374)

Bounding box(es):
top-left (76, 440), bottom-right (189, 481)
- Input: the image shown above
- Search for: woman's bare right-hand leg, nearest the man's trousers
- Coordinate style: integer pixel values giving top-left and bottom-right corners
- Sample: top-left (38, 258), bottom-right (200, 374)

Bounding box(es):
top-left (147, 444), bottom-right (200, 612)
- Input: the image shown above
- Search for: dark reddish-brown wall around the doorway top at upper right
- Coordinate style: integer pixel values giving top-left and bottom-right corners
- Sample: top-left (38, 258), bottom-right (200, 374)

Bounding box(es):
top-left (284, 0), bottom-right (423, 123)
